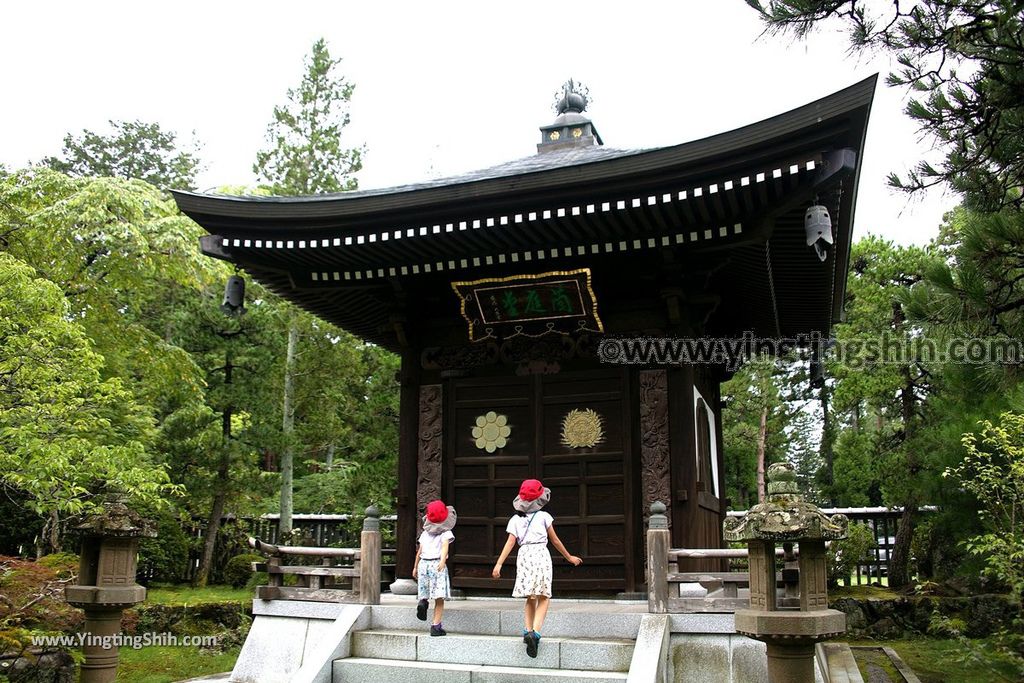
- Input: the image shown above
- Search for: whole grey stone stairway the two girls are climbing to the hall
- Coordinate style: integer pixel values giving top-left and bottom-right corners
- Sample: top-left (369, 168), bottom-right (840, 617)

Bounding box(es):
top-left (333, 603), bottom-right (639, 683)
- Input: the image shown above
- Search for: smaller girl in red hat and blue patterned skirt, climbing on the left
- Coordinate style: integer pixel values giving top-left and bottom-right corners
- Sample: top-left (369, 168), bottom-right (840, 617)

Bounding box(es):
top-left (413, 501), bottom-right (456, 636)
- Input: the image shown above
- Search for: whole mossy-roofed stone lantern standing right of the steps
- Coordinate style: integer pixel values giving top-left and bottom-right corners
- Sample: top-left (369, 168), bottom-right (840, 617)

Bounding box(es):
top-left (724, 463), bottom-right (848, 683)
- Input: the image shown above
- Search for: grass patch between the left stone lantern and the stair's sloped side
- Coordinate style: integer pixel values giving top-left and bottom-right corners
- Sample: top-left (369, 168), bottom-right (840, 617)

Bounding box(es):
top-left (118, 646), bottom-right (239, 683)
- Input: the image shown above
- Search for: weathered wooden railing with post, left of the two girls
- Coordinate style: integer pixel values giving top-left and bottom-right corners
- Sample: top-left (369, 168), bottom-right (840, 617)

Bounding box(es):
top-left (249, 507), bottom-right (393, 605)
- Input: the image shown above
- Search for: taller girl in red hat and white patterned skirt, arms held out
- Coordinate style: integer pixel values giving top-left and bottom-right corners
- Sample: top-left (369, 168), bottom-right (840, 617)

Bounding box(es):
top-left (490, 479), bottom-right (583, 657)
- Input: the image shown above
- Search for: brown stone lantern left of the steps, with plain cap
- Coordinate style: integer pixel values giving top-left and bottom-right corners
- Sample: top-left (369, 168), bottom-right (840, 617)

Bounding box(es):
top-left (65, 501), bottom-right (157, 683)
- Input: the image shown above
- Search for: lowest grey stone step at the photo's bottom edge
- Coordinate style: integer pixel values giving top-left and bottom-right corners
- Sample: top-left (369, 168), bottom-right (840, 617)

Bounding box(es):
top-left (334, 657), bottom-right (627, 683)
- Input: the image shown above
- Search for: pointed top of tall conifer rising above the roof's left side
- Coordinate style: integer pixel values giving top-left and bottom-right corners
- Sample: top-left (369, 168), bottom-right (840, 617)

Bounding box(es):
top-left (253, 38), bottom-right (366, 195)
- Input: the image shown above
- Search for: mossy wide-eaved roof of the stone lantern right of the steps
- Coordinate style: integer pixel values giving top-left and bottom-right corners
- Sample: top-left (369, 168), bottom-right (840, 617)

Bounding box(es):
top-left (723, 463), bottom-right (849, 542)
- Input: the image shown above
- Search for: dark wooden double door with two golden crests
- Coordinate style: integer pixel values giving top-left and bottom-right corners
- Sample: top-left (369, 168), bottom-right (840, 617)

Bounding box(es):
top-left (444, 369), bottom-right (630, 595)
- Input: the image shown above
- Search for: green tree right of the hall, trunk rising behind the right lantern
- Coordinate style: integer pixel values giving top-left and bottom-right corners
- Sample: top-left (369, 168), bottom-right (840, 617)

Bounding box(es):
top-left (829, 237), bottom-right (937, 587)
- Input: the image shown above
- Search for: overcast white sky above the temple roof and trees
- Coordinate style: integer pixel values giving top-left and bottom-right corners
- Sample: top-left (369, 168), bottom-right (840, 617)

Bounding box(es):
top-left (0, 0), bottom-right (956, 244)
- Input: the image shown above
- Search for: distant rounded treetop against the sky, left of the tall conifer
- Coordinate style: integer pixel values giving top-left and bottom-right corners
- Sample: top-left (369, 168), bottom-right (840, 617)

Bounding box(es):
top-left (42, 121), bottom-right (200, 189)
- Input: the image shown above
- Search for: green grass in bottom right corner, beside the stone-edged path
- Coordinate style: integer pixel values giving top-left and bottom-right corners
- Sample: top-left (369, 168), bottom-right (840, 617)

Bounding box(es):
top-left (850, 638), bottom-right (1020, 683)
